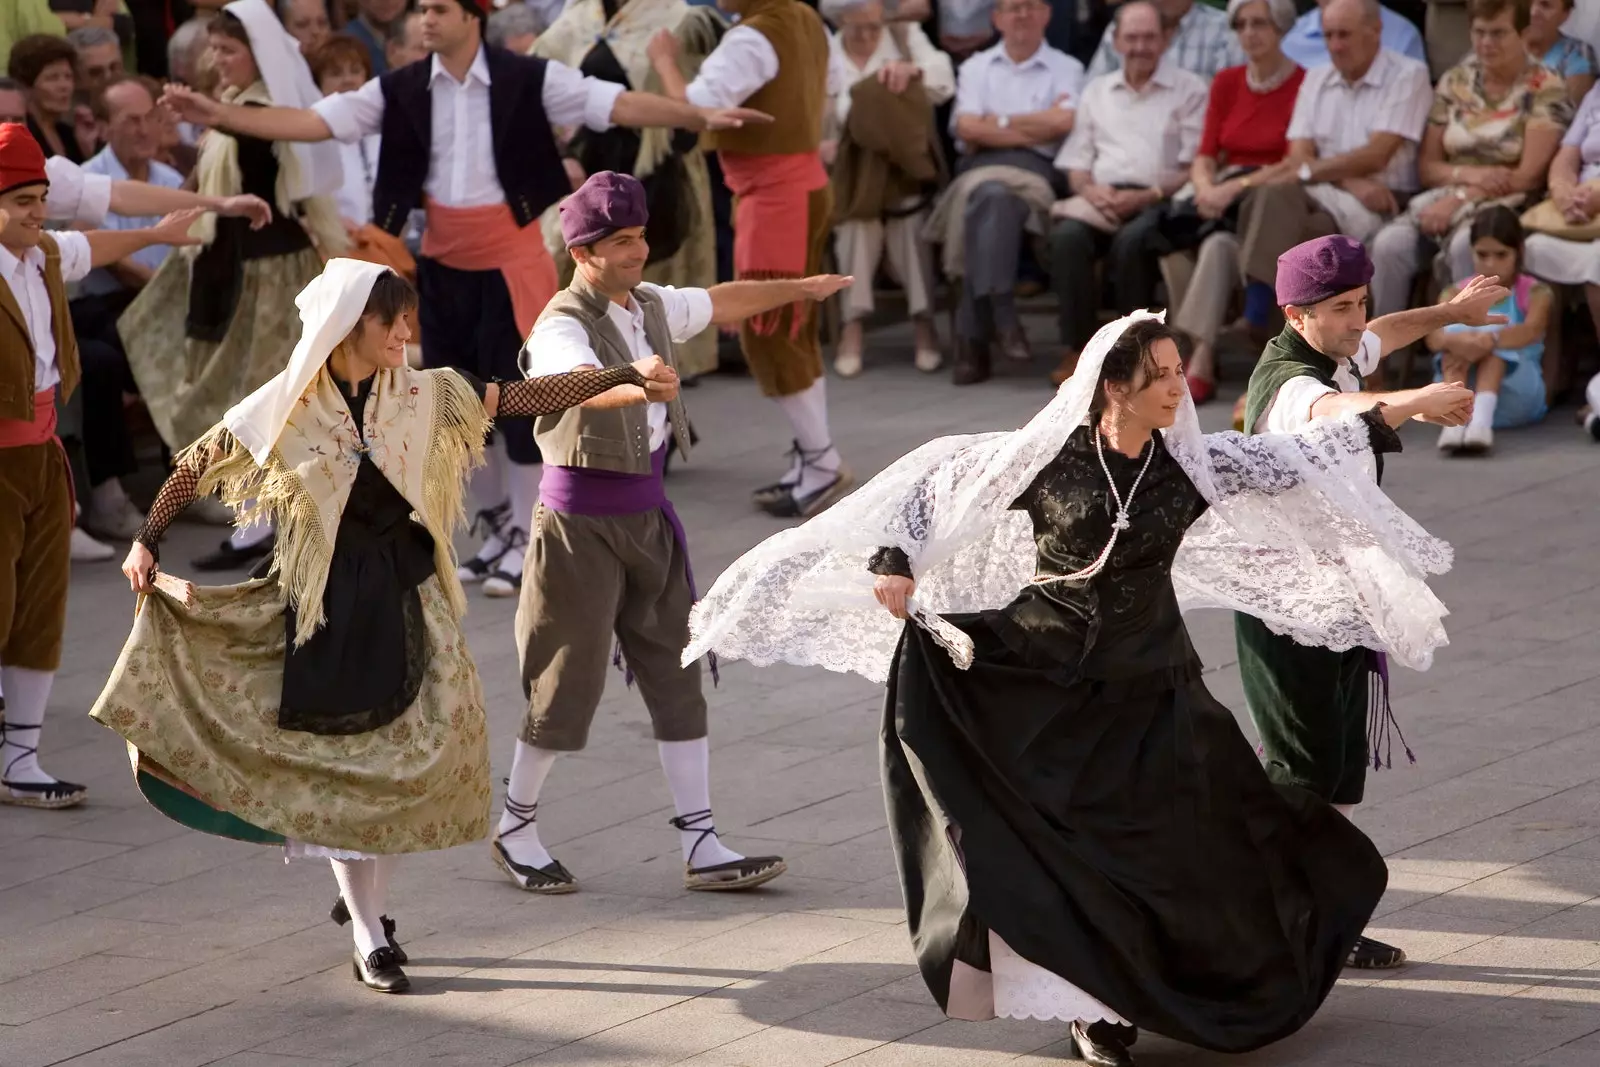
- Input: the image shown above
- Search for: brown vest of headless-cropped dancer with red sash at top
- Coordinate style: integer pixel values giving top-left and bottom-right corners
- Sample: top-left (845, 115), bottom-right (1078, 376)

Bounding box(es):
top-left (706, 0), bottom-right (827, 155)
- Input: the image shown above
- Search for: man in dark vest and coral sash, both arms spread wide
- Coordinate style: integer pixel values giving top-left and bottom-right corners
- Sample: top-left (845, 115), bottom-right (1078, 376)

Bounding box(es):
top-left (162, 0), bottom-right (766, 597)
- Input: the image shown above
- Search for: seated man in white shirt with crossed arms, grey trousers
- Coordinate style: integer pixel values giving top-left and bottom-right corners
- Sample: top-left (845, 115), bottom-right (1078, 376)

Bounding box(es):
top-left (928, 0), bottom-right (1083, 386)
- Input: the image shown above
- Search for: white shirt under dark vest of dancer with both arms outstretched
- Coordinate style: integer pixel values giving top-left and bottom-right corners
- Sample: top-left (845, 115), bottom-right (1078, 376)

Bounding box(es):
top-left (312, 46), bottom-right (626, 208)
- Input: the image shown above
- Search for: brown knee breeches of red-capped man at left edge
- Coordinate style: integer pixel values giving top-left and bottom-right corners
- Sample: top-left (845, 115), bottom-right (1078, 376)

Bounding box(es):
top-left (0, 440), bottom-right (72, 670)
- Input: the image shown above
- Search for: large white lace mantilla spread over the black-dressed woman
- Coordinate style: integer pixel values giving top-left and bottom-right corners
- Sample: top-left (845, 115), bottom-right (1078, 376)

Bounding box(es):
top-left (683, 312), bottom-right (1451, 681)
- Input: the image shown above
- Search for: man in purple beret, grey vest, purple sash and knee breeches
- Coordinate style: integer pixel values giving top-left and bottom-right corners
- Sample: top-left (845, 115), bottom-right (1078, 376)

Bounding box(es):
top-left (494, 171), bottom-right (850, 894)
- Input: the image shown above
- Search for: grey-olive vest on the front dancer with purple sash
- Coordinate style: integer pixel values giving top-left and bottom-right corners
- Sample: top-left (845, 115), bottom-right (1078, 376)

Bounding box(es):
top-left (533, 272), bottom-right (690, 474)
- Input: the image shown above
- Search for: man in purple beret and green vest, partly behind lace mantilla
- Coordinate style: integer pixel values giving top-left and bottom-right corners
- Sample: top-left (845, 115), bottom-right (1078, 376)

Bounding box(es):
top-left (1234, 234), bottom-right (1506, 968)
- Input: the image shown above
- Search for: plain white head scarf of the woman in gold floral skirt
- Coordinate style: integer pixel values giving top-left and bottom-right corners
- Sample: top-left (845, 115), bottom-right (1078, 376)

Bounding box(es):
top-left (222, 260), bottom-right (389, 464)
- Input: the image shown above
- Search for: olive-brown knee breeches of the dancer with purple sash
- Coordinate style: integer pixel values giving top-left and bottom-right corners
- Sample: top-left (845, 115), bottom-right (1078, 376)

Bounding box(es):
top-left (517, 504), bottom-right (706, 752)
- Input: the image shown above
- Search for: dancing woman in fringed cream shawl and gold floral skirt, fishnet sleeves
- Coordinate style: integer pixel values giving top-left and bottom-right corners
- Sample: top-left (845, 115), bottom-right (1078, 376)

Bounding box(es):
top-left (91, 259), bottom-right (677, 993)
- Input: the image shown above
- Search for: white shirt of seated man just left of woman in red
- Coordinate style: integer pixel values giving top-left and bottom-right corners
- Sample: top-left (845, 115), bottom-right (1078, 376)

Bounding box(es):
top-left (1056, 59), bottom-right (1210, 186)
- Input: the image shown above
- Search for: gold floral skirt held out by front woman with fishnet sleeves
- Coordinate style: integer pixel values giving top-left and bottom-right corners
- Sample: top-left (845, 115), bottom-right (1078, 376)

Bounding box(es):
top-left (90, 576), bottom-right (493, 854)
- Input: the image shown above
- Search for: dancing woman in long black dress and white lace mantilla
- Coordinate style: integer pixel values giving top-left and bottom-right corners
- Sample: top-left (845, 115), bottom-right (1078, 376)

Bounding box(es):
top-left (685, 312), bottom-right (1450, 1065)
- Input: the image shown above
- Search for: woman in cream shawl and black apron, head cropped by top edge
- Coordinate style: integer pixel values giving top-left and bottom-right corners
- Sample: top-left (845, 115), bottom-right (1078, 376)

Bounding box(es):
top-left (531, 0), bottom-right (726, 378)
